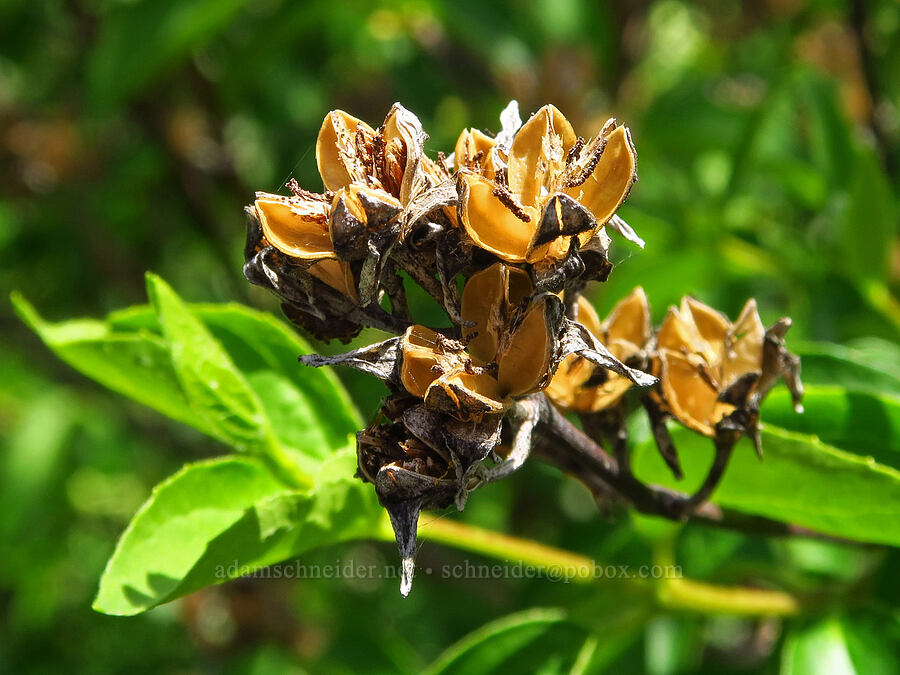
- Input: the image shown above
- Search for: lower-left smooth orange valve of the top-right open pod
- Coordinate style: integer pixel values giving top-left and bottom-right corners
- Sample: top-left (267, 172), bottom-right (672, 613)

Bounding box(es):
top-left (457, 171), bottom-right (540, 263)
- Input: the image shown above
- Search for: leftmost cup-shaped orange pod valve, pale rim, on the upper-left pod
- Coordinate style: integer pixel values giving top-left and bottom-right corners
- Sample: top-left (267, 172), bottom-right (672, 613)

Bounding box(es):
top-left (254, 192), bottom-right (334, 260)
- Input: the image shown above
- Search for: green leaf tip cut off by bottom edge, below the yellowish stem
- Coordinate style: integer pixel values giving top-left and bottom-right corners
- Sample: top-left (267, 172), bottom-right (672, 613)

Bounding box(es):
top-left (423, 608), bottom-right (566, 675)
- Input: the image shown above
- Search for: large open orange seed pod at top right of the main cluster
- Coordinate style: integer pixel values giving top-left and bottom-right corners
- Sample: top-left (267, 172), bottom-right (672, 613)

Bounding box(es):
top-left (456, 105), bottom-right (637, 263)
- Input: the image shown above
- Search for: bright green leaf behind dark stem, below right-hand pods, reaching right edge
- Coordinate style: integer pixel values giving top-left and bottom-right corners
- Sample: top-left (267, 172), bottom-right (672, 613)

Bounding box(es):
top-left (634, 426), bottom-right (900, 546)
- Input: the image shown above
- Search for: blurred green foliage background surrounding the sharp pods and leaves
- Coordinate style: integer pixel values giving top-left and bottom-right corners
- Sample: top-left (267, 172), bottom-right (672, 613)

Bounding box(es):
top-left (0, 0), bottom-right (900, 674)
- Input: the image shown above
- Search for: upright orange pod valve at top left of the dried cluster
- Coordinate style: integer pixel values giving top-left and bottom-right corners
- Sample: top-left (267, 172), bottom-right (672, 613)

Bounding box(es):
top-left (316, 110), bottom-right (375, 190)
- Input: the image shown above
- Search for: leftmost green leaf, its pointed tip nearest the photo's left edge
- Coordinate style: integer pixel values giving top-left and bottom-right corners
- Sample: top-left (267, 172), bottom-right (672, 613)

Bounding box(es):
top-left (12, 293), bottom-right (209, 432)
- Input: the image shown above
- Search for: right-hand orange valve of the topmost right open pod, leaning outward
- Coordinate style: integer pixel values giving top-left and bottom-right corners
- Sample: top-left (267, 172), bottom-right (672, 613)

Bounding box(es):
top-left (565, 127), bottom-right (637, 230)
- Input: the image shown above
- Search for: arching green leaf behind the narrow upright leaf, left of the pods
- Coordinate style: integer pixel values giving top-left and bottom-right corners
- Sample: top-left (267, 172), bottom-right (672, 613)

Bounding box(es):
top-left (107, 303), bottom-right (363, 446)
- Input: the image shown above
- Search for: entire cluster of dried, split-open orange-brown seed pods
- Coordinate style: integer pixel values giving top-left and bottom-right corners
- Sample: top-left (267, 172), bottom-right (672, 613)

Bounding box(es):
top-left (244, 102), bottom-right (800, 594)
